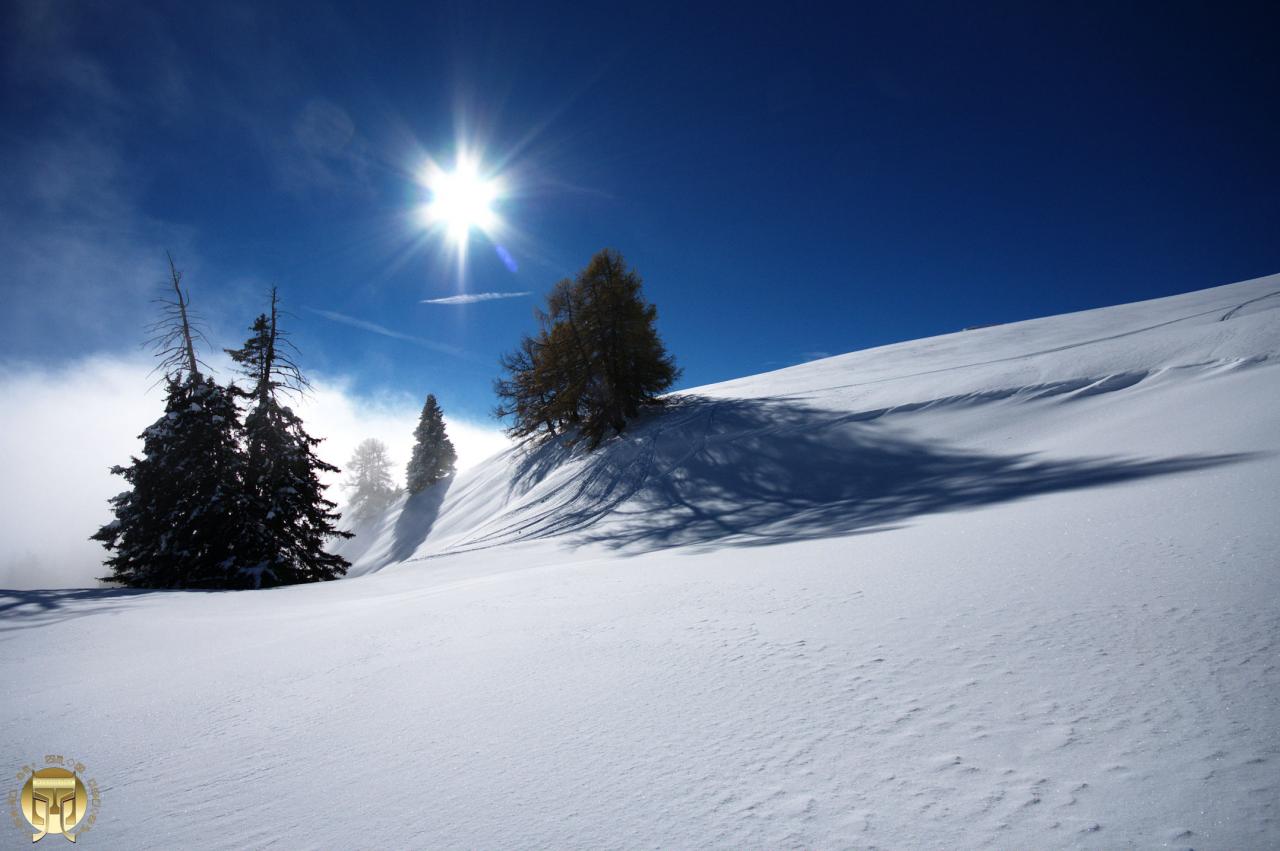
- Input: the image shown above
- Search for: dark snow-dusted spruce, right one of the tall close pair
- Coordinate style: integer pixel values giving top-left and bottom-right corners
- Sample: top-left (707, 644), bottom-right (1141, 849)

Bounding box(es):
top-left (227, 288), bottom-right (352, 587)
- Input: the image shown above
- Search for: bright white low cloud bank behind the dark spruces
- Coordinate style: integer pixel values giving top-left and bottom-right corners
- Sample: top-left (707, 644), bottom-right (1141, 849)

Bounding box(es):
top-left (0, 356), bottom-right (508, 589)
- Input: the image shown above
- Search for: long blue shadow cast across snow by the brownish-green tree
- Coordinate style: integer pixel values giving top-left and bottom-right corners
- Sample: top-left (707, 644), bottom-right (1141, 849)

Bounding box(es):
top-left (471, 397), bottom-right (1251, 553)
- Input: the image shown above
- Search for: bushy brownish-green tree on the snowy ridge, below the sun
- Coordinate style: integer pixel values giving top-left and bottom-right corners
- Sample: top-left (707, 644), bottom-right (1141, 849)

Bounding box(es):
top-left (494, 248), bottom-right (680, 448)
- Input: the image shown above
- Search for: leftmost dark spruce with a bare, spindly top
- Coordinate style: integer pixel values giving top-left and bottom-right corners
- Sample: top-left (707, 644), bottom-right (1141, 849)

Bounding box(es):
top-left (92, 257), bottom-right (247, 589)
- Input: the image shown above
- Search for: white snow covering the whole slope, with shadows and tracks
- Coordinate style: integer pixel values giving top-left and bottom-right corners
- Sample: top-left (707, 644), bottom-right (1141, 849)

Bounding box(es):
top-left (0, 275), bottom-right (1280, 850)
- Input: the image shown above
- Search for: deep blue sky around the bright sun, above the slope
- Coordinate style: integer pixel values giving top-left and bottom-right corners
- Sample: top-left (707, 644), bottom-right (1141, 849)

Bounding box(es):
top-left (0, 3), bottom-right (1280, 416)
